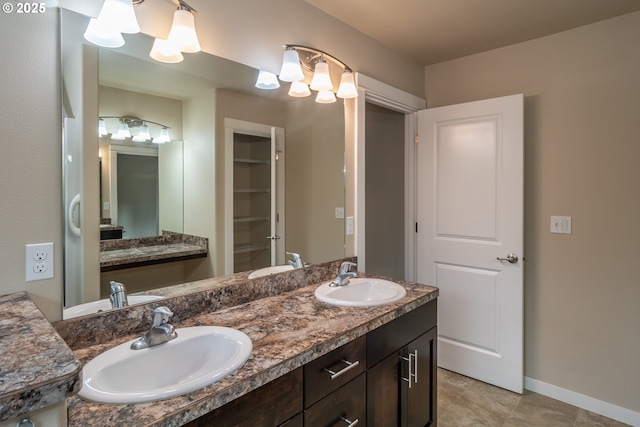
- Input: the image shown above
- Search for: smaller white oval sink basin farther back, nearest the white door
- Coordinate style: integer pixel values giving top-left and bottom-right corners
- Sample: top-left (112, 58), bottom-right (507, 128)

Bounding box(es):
top-left (315, 277), bottom-right (407, 307)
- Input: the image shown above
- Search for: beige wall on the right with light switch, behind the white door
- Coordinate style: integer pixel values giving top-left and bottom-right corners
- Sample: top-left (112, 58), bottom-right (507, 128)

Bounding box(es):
top-left (426, 13), bottom-right (640, 411)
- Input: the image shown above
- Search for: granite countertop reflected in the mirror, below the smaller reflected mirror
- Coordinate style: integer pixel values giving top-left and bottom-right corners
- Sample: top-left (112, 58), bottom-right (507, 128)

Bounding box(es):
top-left (100, 231), bottom-right (209, 271)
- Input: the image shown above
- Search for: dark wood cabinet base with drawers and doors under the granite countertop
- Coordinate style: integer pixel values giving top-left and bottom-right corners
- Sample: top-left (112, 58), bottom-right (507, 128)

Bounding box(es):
top-left (187, 300), bottom-right (437, 427)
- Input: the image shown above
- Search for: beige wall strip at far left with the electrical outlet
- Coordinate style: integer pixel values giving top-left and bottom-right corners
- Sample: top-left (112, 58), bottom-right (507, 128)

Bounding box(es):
top-left (0, 9), bottom-right (62, 320)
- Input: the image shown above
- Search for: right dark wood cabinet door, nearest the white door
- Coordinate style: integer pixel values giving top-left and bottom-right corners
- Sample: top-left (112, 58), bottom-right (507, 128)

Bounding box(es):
top-left (399, 328), bottom-right (437, 427)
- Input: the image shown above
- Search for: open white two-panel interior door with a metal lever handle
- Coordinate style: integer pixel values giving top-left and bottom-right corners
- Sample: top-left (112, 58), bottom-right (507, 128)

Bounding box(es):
top-left (416, 95), bottom-right (523, 393)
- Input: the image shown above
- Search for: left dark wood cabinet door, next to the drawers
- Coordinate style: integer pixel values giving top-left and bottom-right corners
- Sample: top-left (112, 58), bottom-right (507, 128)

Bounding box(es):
top-left (367, 352), bottom-right (404, 427)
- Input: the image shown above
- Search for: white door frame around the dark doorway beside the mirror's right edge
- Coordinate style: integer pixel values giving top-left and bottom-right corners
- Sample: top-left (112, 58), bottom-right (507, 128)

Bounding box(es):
top-left (354, 73), bottom-right (427, 281)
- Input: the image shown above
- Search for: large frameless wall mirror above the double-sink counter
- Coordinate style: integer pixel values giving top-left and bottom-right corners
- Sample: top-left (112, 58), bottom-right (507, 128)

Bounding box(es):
top-left (61, 10), bottom-right (345, 318)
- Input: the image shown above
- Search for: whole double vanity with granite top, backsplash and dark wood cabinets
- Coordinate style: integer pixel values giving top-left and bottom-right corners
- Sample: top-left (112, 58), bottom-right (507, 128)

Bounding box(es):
top-left (3, 261), bottom-right (438, 426)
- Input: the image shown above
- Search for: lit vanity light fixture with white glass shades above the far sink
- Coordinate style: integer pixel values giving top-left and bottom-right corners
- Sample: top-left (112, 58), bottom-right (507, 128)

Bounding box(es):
top-left (256, 44), bottom-right (358, 104)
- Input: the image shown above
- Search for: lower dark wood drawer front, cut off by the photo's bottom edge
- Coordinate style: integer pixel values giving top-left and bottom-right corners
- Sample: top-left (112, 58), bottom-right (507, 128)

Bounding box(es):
top-left (304, 373), bottom-right (367, 427)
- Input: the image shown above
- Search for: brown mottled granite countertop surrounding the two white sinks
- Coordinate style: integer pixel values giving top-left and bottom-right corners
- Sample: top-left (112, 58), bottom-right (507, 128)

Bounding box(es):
top-left (67, 273), bottom-right (438, 427)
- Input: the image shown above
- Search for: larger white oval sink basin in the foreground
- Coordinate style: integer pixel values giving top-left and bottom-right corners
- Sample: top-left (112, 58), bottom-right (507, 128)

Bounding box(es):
top-left (79, 326), bottom-right (253, 404)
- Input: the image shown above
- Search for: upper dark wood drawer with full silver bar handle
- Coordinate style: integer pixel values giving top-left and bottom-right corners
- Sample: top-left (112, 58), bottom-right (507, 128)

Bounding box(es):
top-left (304, 336), bottom-right (367, 408)
